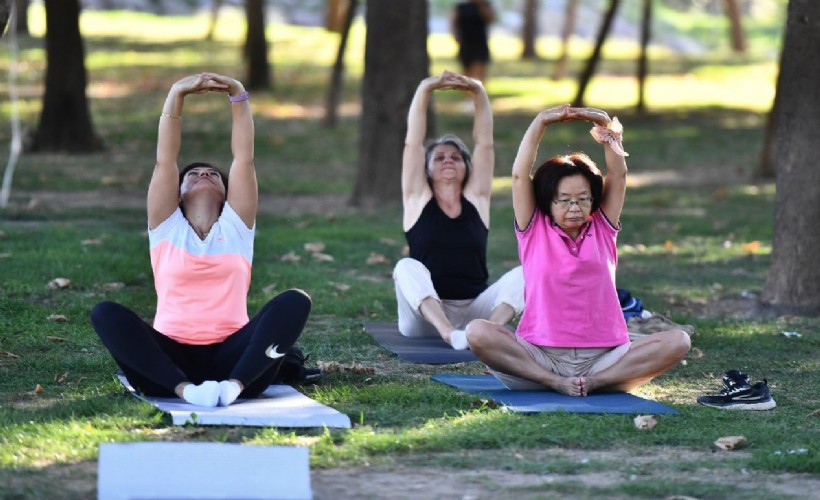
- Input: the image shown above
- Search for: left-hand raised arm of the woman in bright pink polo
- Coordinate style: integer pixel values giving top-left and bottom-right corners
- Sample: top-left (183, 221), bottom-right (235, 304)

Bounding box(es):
top-left (512, 104), bottom-right (570, 229)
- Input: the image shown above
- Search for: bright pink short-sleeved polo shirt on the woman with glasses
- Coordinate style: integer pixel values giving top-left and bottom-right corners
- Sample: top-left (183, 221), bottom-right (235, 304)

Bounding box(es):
top-left (515, 210), bottom-right (629, 347)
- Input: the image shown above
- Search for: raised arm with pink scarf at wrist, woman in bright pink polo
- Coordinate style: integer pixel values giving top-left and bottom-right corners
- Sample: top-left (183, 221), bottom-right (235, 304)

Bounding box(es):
top-left (572, 108), bottom-right (627, 226)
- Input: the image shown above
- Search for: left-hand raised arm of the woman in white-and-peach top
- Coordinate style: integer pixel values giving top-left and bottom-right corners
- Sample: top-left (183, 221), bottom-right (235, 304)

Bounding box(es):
top-left (147, 73), bottom-right (225, 229)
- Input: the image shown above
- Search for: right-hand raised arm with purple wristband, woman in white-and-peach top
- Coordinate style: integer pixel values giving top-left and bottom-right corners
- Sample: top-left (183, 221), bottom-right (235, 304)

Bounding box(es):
top-left (212, 75), bottom-right (259, 228)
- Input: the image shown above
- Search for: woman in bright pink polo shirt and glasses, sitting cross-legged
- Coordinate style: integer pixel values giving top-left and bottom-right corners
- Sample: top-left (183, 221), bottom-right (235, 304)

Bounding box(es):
top-left (467, 105), bottom-right (690, 396)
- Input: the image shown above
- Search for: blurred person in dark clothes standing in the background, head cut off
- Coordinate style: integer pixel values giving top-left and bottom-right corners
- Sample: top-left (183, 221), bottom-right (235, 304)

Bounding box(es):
top-left (450, 0), bottom-right (495, 82)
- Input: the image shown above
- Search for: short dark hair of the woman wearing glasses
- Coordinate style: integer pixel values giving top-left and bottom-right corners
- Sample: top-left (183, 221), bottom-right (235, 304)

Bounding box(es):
top-left (532, 153), bottom-right (604, 221)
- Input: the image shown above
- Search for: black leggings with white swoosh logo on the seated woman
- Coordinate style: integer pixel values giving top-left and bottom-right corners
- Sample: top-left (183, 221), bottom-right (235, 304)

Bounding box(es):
top-left (91, 289), bottom-right (311, 398)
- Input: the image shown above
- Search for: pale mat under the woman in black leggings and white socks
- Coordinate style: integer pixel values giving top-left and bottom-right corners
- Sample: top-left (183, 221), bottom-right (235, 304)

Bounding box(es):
top-left (117, 374), bottom-right (350, 429)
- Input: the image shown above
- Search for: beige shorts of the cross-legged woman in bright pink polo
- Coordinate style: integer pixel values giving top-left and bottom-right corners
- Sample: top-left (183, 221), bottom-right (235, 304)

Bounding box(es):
top-left (490, 335), bottom-right (632, 391)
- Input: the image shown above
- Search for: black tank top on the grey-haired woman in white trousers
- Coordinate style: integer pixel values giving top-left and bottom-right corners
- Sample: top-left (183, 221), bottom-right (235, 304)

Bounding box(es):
top-left (405, 196), bottom-right (489, 300)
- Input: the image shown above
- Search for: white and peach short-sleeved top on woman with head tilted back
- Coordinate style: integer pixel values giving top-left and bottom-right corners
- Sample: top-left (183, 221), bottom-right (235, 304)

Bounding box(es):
top-left (148, 203), bottom-right (256, 345)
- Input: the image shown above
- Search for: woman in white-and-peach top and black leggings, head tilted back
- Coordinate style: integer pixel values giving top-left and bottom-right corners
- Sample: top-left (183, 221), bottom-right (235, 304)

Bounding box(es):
top-left (91, 73), bottom-right (311, 406)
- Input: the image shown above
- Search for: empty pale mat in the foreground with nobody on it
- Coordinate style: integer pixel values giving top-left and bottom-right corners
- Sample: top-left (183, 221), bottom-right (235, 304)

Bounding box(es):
top-left (97, 443), bottom-right (313, 500)
